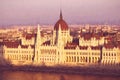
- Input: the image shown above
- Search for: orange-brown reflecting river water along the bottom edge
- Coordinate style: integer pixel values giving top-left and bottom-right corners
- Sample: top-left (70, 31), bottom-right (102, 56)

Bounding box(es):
top-left (0, 71), bottom-right (120, 80)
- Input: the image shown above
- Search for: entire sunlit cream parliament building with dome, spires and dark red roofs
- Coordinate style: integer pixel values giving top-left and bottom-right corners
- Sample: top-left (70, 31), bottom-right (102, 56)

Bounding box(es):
top-left (0, 12), bottom-right (120, 66)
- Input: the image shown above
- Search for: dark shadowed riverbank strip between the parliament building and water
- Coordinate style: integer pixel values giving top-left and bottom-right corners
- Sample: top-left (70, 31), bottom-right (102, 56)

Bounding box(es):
top-left (0, 66), bottom-right (120, 77)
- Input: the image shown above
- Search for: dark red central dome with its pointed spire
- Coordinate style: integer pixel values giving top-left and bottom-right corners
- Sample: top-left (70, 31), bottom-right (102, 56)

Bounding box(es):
top-left (54, 12), bottom-right (68, 31)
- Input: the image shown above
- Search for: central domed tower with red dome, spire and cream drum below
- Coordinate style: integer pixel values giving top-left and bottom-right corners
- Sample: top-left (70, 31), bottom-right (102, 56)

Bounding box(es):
top-left (52, 10), bottom-right (72, 46)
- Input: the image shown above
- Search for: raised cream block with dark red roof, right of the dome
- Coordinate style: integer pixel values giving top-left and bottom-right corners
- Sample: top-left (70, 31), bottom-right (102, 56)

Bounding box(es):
top-left (79, 33), bottom-right (107, 46)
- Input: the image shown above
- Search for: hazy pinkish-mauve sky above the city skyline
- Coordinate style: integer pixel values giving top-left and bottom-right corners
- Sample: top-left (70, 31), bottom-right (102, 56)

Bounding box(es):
top-left (0, 0), bottom-right (120, 25)
